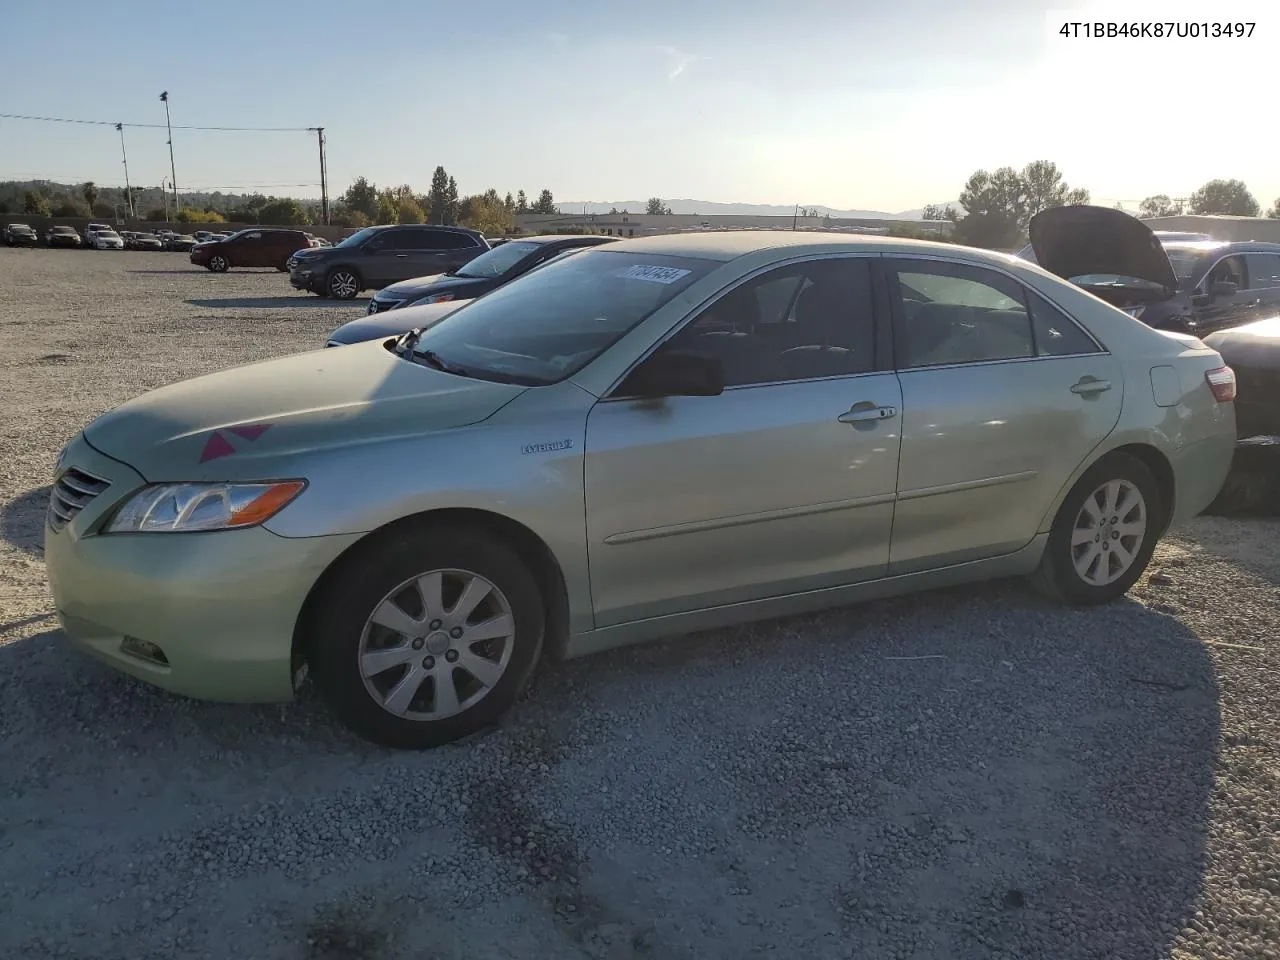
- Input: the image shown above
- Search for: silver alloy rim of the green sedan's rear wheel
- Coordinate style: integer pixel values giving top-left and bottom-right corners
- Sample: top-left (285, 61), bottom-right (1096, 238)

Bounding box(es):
top-left (1071, 480), bottom-right (1147, 586)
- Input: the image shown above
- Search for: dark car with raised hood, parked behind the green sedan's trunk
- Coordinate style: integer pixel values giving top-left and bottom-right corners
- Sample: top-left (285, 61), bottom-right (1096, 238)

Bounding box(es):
top-left (1019, 206), bottom-right (1280, 337)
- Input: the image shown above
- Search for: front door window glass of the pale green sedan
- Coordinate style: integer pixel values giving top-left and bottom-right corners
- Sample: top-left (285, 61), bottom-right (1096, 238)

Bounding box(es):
top-left (662, 257), bottom-right (876, 387)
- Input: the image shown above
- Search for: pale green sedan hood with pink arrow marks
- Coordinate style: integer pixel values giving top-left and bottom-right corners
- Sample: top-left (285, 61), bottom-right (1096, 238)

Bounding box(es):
top-left (84, 343), bottom-right (527, 481)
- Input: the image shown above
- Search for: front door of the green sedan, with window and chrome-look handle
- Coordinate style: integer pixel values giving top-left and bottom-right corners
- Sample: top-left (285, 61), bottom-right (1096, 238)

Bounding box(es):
top-left (585, 257), bottom-right (902, 626)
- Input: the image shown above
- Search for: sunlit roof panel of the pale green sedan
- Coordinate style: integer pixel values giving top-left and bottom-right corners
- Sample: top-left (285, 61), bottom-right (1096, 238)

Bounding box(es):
top-left (608, 230), bottom-right (977, 264)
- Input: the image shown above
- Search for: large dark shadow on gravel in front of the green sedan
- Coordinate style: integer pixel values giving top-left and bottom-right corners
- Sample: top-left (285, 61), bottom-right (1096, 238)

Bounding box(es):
top-left (0, 585), bottom-right (1219, 960)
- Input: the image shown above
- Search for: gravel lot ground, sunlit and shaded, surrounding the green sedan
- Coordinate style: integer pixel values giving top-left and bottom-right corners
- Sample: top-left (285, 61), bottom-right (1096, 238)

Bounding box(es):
top-left (0, 250), bottom-right (1280, 960)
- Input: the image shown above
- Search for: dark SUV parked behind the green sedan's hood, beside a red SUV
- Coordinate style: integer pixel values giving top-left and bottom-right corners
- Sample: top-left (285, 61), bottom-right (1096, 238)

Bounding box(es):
top-left (288, 224), bottom-right (489, 300)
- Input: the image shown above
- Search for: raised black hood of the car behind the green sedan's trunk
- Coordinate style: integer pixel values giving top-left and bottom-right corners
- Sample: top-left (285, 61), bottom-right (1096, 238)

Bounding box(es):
top-left (1029, 205), bottom-right (1178, 297)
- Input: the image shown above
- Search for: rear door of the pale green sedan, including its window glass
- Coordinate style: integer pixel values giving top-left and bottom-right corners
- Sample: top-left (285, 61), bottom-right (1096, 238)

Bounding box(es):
top-left (887, 259), bottom-right (1116, 573)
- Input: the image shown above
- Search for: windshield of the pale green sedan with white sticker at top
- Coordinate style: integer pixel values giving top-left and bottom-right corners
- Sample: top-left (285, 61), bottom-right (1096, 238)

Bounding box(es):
top-left (416, 250), bottom-right (719, 387)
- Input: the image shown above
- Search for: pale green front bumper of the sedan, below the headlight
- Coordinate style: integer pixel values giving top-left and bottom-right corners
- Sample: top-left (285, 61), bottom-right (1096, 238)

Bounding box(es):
top-left (45, 438), bottom-right (358, 703)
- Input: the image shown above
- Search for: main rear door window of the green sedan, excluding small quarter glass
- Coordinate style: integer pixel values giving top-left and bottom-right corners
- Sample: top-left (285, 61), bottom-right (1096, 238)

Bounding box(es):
top-left (893, 261), bottom-right (1036, 367)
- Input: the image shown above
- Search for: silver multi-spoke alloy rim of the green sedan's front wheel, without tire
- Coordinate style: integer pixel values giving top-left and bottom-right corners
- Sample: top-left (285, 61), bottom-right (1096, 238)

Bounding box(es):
top-left (357, 570), bottom-right (516, 721)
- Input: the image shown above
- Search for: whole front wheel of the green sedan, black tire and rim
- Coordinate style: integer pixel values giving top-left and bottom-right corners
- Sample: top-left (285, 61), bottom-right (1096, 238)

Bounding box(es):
top-left (307, 525), bottom-right (545, 750)
